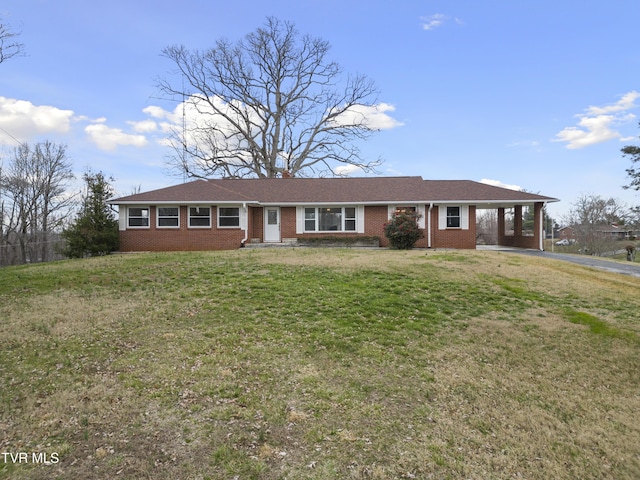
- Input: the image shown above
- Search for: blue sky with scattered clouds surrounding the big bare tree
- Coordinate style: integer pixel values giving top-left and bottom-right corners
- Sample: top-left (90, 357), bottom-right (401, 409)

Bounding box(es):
top-left (0, 0), bottom-right (640, 216)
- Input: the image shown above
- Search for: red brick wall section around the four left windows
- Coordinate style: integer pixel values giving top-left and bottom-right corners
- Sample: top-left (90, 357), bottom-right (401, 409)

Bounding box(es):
top-left (120, 206), bottom-right (244, 252)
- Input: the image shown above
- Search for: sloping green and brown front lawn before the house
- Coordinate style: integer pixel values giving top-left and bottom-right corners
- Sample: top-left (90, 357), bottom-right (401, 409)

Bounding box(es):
top-left (0, 249), bottom-right (640, 480)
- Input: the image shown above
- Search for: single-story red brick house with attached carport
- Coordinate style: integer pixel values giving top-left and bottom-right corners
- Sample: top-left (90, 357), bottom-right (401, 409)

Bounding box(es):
top-left (109, 176), bottom-right (558, 251)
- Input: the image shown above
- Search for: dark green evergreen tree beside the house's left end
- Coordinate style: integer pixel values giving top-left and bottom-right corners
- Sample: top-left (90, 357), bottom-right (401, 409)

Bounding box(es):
top-left (62, 172), bottom-right (119, 258)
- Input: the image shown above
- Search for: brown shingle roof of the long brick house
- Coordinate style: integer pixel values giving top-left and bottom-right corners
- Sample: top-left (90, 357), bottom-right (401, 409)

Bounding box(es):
top-left (110, 176), bottom-right (558, 205)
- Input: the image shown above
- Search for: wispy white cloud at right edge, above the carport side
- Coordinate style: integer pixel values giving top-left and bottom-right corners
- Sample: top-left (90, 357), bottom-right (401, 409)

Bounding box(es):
top-left (555, 90), bottom-right (640, 149)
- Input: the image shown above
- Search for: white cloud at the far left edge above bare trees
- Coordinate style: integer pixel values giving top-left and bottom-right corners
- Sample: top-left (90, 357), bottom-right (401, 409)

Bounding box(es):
top-left (0, 97), bottom-right (74, 143)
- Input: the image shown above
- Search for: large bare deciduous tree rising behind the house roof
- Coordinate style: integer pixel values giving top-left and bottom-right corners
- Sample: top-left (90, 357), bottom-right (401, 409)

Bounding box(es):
top-left (158, 18), bottom-right (382, 177)
